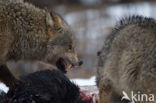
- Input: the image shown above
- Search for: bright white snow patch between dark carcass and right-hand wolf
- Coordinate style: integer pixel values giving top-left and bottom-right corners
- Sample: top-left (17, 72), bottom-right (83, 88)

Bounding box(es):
top-left (71, 76), bottom-right (96, 86)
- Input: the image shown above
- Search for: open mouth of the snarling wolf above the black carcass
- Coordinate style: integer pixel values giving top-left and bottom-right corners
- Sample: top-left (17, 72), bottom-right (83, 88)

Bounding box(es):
top-left (56, 57), bottom-right (74, 73)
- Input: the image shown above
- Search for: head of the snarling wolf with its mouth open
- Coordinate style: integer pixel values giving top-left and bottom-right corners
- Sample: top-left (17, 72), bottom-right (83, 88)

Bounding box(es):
top-left (46, 13), bottom-right (82, 72)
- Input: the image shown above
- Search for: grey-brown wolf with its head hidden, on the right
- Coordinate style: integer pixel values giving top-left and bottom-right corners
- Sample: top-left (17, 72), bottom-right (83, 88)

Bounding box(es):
top-left (97, 16), bottom-right (156, 103)
